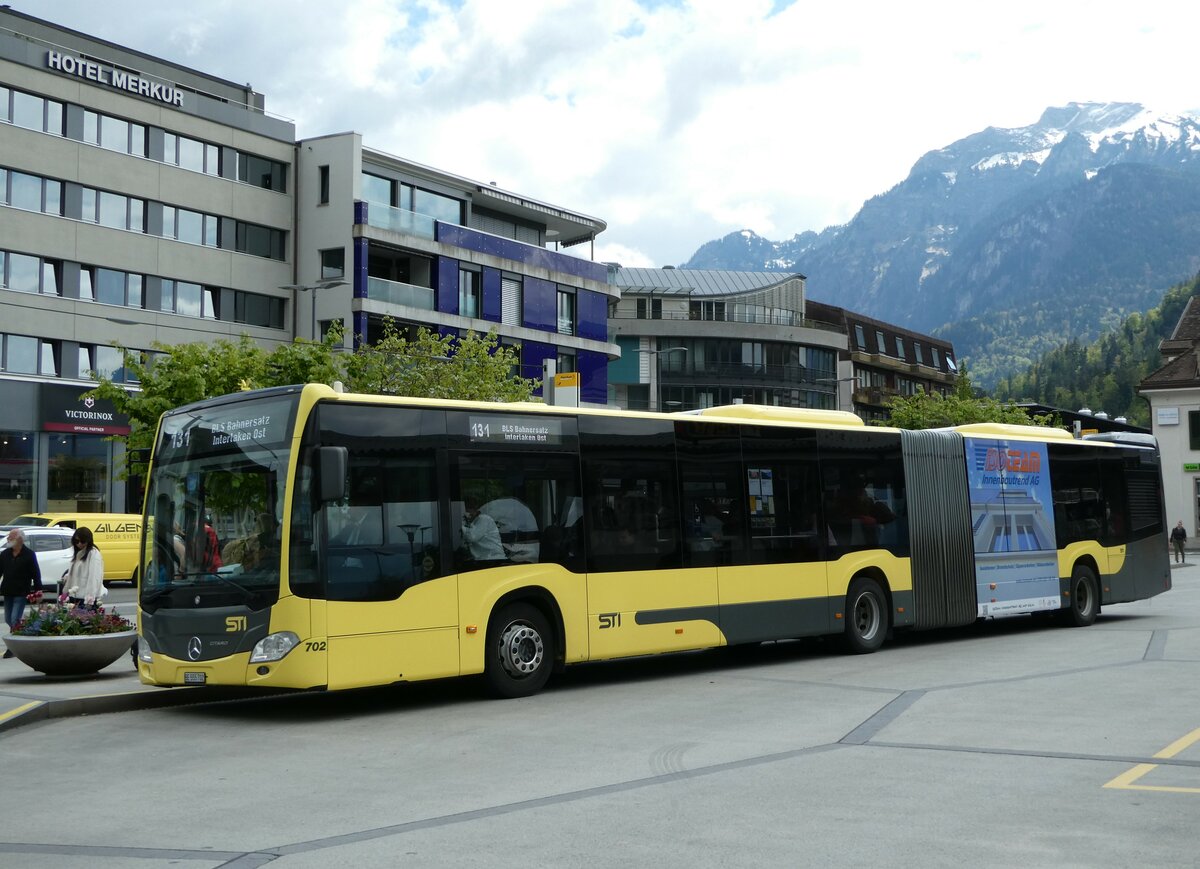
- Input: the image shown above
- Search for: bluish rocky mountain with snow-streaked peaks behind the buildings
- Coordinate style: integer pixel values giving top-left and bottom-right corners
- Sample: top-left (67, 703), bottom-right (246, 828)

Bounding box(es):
top-left (683, 103), bottom-right (1200, 385)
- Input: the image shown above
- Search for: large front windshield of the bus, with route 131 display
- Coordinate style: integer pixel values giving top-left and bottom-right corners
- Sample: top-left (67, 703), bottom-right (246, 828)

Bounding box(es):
top-left (140, 394), bottom-right (296, 609)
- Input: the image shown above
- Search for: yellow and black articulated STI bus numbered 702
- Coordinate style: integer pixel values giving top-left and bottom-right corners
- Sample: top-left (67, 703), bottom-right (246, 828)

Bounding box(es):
top-left (138, 384), bottom-right (1171, 696)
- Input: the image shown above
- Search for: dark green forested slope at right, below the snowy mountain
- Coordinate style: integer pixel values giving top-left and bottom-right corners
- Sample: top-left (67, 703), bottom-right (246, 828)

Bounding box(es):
top-left (995, 270), bottom-right (1200, 427)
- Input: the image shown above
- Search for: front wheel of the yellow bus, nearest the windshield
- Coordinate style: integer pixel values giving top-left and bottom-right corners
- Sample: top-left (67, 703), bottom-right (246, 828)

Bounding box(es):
top-left (484, 604), bottom-right (554, 697)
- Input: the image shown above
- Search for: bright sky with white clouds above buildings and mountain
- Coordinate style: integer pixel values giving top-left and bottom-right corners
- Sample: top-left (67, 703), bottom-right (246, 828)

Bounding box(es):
top-left (25, 0), bottom-right (1200, 265)
